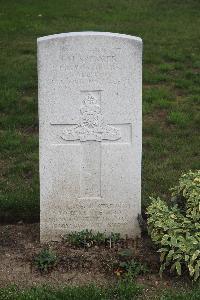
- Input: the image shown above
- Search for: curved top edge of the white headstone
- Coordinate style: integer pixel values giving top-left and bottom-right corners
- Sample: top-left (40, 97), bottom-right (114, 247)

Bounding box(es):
top-left (37, 31), bottom-right (142, 43)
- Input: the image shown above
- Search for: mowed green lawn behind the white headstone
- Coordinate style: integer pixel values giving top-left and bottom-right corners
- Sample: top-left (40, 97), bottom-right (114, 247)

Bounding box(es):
top-left (0, 0), bottom-right (200, 222)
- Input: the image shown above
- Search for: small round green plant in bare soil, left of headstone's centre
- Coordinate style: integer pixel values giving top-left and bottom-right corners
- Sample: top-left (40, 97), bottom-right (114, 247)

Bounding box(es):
top-left (34, 249), bottom-right (58, 272)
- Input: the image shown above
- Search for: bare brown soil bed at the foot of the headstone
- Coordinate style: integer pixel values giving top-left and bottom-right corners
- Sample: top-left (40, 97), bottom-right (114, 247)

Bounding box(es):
top-left (0, 224), bottom-right (189, 290)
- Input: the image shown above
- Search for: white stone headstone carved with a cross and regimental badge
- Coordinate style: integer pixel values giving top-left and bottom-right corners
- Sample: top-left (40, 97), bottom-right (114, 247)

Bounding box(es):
top-left (38, 32), bottom-right (142, 241)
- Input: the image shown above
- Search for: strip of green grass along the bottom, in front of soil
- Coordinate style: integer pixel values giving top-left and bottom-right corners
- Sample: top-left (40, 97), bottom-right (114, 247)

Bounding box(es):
top-left (0, 280), bottom-right (200, 300)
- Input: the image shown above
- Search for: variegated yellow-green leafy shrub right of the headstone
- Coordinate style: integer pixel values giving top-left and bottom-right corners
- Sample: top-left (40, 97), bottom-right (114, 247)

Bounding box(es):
top-left (147, 170), bottom-right (200, 280)
